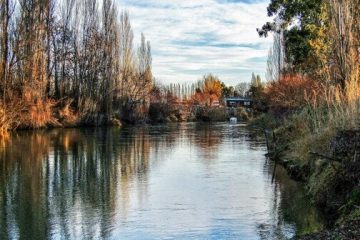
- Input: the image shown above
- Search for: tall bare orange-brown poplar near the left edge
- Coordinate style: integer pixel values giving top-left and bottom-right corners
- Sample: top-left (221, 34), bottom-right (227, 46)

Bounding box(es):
top-left (15, 0), bottom-right (49, 102)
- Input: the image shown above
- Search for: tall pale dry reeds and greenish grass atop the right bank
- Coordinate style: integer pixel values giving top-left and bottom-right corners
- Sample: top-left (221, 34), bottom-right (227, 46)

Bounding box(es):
top-left (278, 75), bottom-right (360, 164)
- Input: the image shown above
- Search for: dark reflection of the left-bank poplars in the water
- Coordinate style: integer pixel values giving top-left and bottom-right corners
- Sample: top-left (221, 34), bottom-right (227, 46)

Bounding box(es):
top-left (0, 129), bottom-right (151, 239)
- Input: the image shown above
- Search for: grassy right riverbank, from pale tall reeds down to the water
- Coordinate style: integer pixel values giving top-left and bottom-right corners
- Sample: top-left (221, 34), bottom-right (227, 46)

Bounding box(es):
top-left (252, 84), bottom-right (360, 235)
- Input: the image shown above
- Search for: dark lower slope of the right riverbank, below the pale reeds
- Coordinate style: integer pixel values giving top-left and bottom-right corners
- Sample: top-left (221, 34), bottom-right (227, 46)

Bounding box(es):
top-left (250, 112), bottom-right (360, 239)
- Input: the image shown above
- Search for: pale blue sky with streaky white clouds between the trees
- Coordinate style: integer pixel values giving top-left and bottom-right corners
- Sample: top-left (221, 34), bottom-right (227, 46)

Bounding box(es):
top-left (117, 0), bottom-right (272, 85)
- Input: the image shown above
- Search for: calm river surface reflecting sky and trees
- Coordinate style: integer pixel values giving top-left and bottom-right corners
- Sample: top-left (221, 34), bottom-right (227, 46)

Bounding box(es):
top-left (0, 124), bottom-right (322, 239)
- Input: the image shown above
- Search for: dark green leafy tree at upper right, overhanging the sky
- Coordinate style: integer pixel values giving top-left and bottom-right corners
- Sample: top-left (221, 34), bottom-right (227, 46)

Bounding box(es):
top-left (257, 0), bottom-right (329, 76)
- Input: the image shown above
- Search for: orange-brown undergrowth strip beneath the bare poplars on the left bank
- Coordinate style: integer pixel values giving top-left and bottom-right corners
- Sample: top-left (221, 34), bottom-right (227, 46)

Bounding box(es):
top-left (0, 100), bottom-right (121, 136)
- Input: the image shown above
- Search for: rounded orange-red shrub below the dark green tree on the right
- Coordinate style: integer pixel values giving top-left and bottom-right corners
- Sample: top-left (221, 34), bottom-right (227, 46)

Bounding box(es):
top-left (265, 74), bottom-right (321, 109)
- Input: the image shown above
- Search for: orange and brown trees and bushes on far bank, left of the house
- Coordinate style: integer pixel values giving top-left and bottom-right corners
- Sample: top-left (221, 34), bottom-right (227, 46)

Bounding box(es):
top-left (149, 74), bottom-right (232, 122)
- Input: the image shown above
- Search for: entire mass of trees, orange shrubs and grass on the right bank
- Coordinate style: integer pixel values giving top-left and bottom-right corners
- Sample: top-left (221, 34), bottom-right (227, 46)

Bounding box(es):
top-left (259, 0), bottom-right (360, 228)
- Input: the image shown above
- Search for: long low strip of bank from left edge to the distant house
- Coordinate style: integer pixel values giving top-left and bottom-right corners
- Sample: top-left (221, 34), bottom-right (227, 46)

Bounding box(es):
top-left (0, 100), bottom-right (253, 134)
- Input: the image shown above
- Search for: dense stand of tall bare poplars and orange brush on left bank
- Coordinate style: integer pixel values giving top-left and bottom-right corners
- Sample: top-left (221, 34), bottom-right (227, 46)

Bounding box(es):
top-left (0, 0), bottom-right (153, 135)
